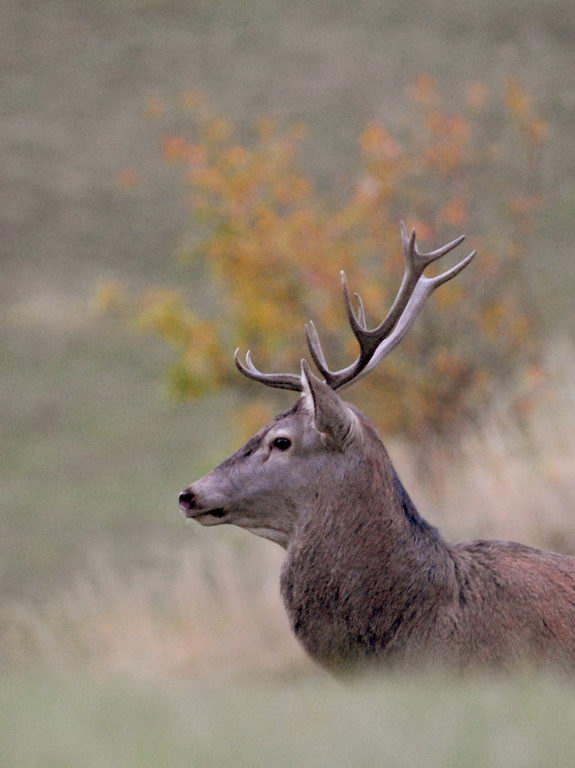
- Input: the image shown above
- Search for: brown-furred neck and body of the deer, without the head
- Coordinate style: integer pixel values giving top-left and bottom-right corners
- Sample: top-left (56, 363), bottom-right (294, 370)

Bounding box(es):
top-left (281, 413), bottom-right (575, 669)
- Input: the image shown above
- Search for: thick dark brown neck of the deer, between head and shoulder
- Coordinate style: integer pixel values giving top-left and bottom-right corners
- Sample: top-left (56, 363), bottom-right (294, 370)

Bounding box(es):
top-left (281, 432), bottom-right (454, 666)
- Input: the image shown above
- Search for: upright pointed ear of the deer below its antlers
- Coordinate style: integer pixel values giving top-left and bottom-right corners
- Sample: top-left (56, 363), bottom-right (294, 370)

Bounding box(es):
top-left (301, 360), bottom-right (358, 451)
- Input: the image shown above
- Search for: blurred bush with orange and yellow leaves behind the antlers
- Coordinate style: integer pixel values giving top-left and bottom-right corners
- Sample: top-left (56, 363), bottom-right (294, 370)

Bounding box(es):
top-left (99, 76), bottom-right (546, 440)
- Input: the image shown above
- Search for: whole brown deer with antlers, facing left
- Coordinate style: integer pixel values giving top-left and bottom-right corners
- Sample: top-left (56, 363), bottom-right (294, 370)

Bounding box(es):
top-left (179, 223), bottom-right (575, 672)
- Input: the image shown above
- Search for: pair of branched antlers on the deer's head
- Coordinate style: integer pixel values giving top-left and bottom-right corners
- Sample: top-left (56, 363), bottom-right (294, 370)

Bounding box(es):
top-left (235, 222), bottom-right (477, 392)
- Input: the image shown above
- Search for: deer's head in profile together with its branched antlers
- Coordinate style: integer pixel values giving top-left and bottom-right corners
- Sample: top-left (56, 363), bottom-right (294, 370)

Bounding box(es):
top-left (179, 219), bottom-right (475, 548)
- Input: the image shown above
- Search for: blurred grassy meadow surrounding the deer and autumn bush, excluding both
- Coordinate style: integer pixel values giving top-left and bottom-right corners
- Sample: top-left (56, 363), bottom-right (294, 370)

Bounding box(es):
top-left (0, 0), bottom-right (575, 768)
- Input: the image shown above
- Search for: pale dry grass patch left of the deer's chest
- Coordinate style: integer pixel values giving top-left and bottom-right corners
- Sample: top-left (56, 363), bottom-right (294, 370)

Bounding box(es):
top-left (4, 542), bottom-right (306, 679)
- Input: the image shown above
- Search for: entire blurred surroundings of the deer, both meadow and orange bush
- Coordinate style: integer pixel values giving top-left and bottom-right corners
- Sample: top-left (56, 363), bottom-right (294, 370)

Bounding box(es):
top-left (0, 0), bottom-right (575, 766)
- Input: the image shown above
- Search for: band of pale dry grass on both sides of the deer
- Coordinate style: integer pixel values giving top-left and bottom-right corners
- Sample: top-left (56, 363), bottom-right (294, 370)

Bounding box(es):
top-left (3, 347), bottom-right (575, 678)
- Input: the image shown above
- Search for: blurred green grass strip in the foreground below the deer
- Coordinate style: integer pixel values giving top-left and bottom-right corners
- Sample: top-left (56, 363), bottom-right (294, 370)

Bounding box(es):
top-left (0, 674), bottom-right (575, 768)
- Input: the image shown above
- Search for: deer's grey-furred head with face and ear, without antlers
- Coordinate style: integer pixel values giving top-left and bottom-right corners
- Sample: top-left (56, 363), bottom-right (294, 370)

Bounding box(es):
top-left (180, 368), bottom-right (360, 548)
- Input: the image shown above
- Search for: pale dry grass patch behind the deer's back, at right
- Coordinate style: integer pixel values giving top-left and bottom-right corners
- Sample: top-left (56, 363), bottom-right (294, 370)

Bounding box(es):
top-left (398, 344), bottom-right (575, 554)
